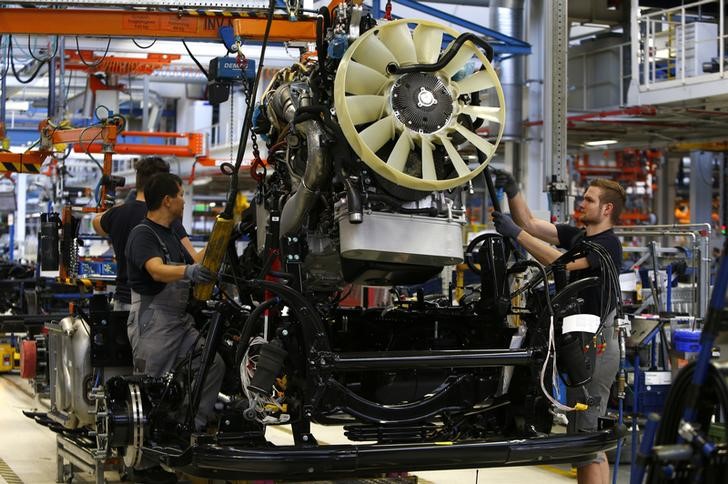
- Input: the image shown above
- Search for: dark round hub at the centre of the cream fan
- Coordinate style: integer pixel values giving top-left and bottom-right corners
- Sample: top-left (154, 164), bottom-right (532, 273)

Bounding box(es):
top-left (392, 72), bottom-right (453, 134)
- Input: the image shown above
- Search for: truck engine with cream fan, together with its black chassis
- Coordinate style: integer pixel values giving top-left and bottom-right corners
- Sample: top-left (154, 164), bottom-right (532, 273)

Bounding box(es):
top-left (27, 2), bottom-right (618, 479)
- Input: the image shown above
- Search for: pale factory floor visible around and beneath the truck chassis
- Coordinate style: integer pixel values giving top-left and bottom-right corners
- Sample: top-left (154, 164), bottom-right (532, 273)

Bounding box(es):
top-left (0, 374), bottom-right (629, 484)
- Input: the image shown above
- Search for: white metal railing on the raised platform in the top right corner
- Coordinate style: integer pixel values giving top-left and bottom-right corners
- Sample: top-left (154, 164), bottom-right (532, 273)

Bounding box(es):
top-left (633, 0), bottom-right (726, 89)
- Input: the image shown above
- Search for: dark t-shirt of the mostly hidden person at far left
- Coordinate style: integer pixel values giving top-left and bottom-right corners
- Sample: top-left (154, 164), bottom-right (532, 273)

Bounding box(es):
top-left (100, 200), bottom-right (187, 304)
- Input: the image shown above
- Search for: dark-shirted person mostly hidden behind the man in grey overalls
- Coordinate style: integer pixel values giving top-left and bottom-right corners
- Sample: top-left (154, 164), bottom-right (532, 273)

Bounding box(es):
top-left (93, 156), bottom-right (204, 311)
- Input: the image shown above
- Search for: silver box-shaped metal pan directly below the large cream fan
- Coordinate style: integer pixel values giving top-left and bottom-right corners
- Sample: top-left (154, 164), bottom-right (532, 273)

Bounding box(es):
top-left (338, 212), bottom-right (463, 266)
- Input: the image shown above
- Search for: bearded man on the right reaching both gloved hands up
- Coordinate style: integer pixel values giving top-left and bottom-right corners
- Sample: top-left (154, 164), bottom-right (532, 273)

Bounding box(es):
top-left (493, 170), bottom-right (626, 484)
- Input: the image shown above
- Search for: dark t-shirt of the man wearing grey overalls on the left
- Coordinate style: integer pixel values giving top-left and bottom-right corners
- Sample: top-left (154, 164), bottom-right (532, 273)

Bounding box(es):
top-left (126, 218), bottom-right (194, 296)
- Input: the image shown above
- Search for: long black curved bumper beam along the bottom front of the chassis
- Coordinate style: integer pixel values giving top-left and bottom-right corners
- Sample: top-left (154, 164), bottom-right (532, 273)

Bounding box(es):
top-left (152, 429), bottom-right (622, 479)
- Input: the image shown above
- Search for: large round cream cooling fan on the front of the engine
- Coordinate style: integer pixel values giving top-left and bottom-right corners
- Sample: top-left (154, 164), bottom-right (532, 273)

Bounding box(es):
top-left (334, 19), bottom-right (505, 191)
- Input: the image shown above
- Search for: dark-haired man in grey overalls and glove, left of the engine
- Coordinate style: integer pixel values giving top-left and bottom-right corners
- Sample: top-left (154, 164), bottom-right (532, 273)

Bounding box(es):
top-left (126, 173), bottom-right (225, 480)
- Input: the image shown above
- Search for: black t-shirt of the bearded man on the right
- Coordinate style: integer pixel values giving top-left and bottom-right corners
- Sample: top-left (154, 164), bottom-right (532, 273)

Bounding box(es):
top-left (556, 224), bottom-right (622, 316)
